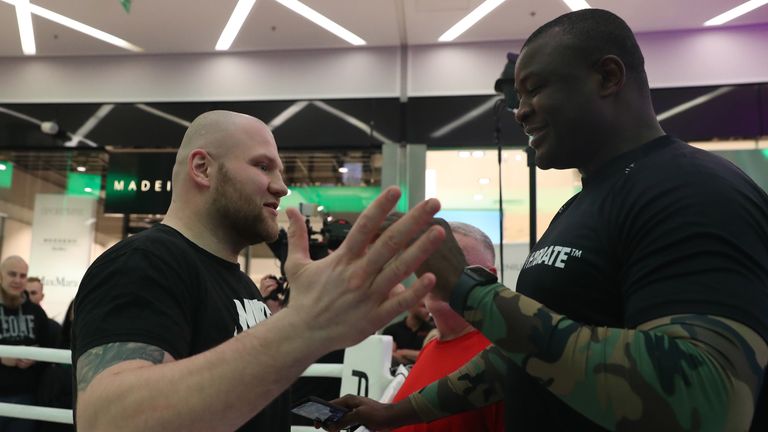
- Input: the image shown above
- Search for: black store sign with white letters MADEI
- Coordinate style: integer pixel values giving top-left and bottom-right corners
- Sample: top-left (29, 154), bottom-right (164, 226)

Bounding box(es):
top-left (104, 153), bottom-right (176, 214)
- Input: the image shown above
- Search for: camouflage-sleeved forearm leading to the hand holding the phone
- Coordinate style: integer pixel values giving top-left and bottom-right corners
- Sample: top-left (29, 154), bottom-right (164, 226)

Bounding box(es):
top-left (408, 346), bottom-right (509, 422)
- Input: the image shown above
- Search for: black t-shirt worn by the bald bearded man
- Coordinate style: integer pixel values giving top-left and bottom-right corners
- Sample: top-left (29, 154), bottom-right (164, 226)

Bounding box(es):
top-left (72, 225), bottom-right (295, 431)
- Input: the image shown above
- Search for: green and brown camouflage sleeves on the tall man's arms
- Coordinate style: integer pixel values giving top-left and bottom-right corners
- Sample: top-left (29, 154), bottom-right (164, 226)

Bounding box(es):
top-left (410, 284), bottom-right (768, 431)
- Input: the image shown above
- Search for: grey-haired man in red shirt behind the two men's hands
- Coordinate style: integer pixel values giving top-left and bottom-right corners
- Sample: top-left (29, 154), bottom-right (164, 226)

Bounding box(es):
top-left (392, 222), bottom-right (504, 432)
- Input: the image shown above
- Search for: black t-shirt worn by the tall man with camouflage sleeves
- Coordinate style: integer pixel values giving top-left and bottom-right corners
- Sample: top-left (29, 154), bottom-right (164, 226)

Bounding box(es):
top-left (506, 136), bottom-right (768, 431)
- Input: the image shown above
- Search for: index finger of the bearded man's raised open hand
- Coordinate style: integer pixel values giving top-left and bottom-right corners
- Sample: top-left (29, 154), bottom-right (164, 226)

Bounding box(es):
top-left (340, 186), bottom-right (400, 257)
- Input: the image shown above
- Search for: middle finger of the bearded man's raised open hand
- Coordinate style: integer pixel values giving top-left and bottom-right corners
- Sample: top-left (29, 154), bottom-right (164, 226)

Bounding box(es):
top-left (364, 199), bottom-right (440, 276)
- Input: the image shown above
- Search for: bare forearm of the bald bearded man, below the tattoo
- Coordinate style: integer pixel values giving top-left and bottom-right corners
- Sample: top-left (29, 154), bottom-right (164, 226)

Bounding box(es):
top-left (77, 311), bottom-right (324, 431)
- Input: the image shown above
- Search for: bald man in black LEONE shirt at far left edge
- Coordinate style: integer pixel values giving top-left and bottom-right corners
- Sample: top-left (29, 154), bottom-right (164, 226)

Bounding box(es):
top-left (0, 255), bottom-right (52, 432)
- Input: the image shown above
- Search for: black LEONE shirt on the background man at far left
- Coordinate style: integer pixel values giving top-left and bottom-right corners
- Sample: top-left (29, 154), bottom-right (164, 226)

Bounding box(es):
top-left (0, 296), bottom-right (53, 396)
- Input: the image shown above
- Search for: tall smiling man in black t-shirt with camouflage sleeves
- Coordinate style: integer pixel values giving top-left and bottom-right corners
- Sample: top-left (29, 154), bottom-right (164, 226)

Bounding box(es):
top-left (328, 9), bottom-right (768, 432)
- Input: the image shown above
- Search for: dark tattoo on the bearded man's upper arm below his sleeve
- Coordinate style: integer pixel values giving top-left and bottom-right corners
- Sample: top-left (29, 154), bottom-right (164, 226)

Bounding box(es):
top-left (77, 342), bottom-right (166, 392)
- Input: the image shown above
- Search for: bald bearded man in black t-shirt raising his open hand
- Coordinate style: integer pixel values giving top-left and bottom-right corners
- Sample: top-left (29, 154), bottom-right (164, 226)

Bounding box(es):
top-left (72, 111), bottom-right (445, 431)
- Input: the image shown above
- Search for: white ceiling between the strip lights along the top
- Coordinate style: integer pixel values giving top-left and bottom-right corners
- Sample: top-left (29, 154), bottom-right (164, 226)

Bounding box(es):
top-left (0, 0), bottom-right (768, 57)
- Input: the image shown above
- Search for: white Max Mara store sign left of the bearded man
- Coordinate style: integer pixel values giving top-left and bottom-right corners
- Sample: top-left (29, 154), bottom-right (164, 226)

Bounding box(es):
top-left (29, 194), bottom-right (97, 321)
